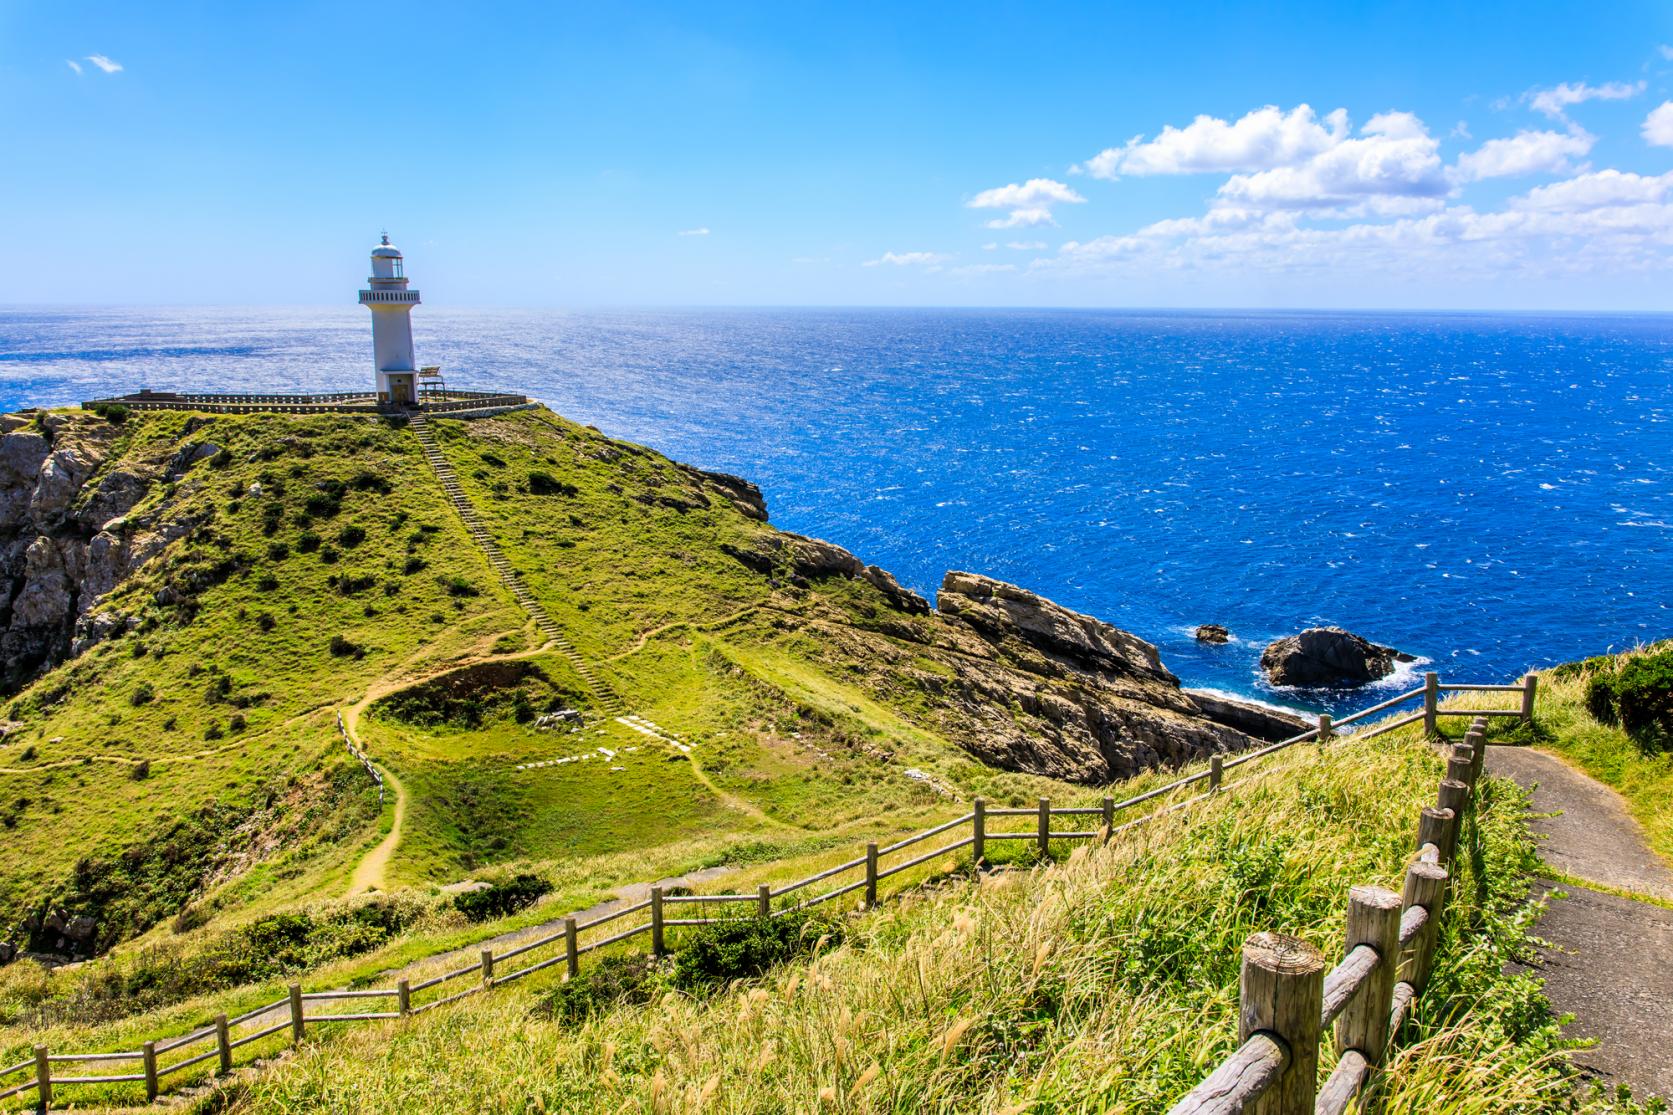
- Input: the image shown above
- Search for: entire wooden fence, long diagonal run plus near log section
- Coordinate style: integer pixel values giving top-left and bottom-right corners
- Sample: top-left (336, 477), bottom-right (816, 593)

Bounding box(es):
top-left (0, 673), bottom-right (1534, 1115)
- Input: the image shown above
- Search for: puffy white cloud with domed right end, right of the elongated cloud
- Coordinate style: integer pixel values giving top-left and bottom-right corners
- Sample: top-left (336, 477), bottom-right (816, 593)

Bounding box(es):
top-left (1218, 112), bottom-right (1450, 213)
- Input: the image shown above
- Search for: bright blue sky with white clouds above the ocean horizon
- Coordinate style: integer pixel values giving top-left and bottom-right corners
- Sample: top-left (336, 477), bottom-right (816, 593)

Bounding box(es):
top-left (0, 0), bottom-right (1673, 310)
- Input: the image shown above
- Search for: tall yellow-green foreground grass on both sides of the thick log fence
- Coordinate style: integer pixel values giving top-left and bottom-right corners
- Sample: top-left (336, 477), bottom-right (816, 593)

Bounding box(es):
top-left (202, 732), bottom-right (1606, 1112)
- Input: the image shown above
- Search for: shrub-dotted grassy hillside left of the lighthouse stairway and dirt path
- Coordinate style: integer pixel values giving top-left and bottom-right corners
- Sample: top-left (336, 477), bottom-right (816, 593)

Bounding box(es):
top-left (0, 414), bottom-right (522, 929)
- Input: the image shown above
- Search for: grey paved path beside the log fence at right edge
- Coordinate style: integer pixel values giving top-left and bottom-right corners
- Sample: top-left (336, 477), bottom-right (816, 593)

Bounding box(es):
top-left (1487, 747), bottom-right (1673, 1098)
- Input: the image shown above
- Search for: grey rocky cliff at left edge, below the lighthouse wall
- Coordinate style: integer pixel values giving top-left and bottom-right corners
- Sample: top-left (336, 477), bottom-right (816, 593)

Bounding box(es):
top-left (0, 414), bottom-right (154, 695)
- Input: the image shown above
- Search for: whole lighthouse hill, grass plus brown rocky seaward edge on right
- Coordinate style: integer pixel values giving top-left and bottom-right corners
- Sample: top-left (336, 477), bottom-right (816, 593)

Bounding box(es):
top-left (0, 401), bottom-right (1278, 971)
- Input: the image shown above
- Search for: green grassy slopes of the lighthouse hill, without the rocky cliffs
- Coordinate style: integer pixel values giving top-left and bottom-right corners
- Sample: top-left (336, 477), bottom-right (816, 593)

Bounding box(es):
top-left (0, 403), bottom-right (1137, 946)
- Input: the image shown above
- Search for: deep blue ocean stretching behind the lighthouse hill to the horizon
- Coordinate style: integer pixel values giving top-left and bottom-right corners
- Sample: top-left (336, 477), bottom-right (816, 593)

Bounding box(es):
top-left (0, 306), bottom-right (1673, 708)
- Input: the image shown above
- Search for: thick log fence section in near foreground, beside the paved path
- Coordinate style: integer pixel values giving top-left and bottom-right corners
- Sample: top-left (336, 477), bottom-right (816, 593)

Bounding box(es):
top-left (1169, 716), bottom-right (1499, 1115)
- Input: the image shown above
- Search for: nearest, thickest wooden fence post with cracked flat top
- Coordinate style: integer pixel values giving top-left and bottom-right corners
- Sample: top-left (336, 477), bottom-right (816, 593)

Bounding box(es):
top-left (1238, 933), bottom-right (1325, 1115)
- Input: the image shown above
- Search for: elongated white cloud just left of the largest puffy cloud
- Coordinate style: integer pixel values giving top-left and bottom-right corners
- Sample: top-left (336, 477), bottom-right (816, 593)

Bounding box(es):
top-left (1079, 104), bottom-right (1348, 179)
